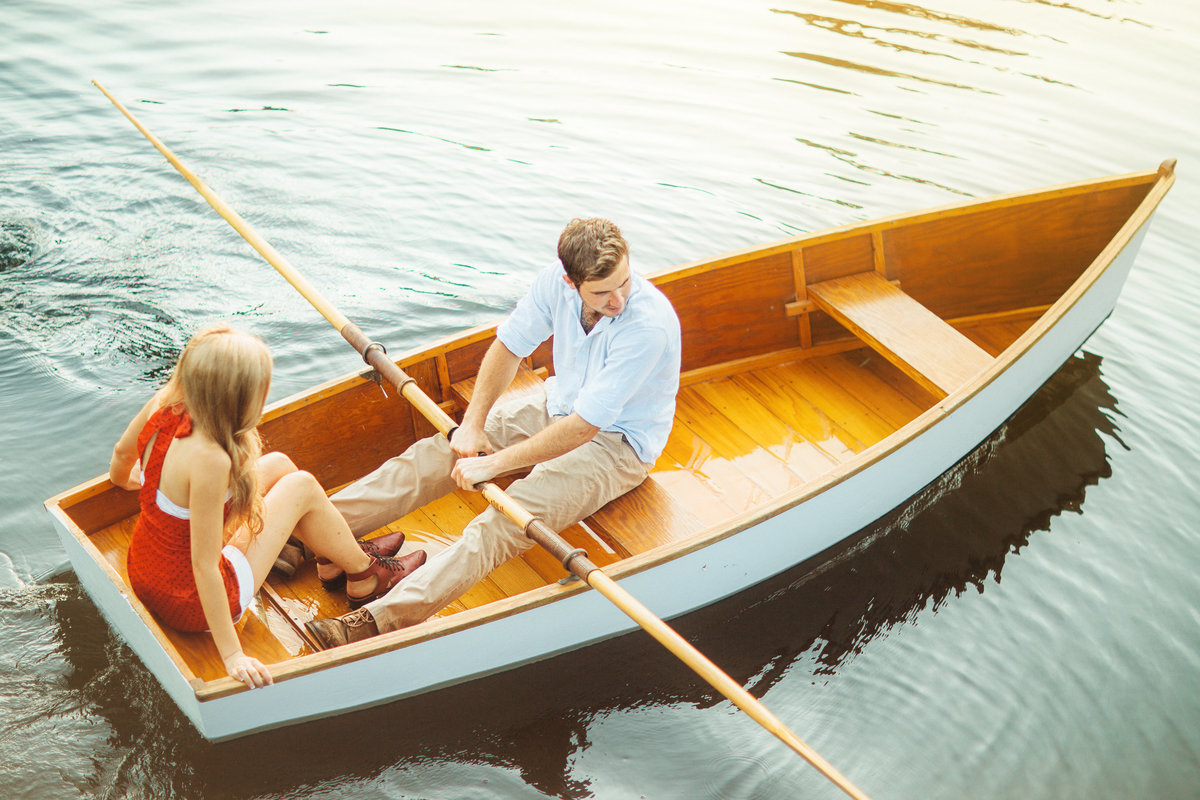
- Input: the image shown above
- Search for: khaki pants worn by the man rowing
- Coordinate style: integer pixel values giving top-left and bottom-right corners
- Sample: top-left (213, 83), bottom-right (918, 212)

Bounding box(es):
top-left (332, 393), bottom-right (650, 632)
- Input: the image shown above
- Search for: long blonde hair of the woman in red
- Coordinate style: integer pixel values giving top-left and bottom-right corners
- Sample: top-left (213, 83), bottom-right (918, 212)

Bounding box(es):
top-left (162, 325), bottom-right (271, 535)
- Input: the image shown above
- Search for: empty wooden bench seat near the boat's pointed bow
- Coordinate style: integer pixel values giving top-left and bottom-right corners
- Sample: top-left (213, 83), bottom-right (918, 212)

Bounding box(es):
top-left (808, 272), bottom-right (992, 397)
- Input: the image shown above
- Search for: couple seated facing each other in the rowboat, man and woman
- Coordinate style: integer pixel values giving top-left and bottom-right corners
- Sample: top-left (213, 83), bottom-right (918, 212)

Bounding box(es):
top-left (109, 218), bottom-right (680, 687)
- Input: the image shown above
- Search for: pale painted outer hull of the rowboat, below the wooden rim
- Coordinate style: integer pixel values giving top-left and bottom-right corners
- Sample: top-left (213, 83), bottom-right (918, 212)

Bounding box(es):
top-left (51, 228), bottom-right (1145, 740)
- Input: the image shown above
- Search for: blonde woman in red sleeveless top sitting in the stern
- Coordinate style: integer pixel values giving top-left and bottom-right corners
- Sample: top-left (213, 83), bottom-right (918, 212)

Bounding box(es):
top-left (109, 326), bottom-right (425, 688)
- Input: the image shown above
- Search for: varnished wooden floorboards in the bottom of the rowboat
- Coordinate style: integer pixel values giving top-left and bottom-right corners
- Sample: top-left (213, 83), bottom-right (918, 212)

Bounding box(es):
top-left (92, 320), bottom-right (1032, 680)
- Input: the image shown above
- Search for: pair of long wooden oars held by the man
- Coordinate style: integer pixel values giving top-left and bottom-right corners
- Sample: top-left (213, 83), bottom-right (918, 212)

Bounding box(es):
top-left (92, 80), bottom-right (866, 800)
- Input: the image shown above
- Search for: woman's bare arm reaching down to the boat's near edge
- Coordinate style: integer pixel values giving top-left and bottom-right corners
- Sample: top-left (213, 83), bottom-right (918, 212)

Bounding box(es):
top-left (187, 445), bottom-right (271, 688)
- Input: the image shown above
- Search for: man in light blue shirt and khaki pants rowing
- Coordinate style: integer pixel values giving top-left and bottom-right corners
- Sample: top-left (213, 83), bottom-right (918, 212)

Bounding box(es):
top-left (307, 218), bottom-right (680, 648)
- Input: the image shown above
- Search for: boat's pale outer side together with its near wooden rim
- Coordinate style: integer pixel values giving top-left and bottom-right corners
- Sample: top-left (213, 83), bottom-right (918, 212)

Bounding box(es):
top-left (47, 164), bottom-right (1169, 740)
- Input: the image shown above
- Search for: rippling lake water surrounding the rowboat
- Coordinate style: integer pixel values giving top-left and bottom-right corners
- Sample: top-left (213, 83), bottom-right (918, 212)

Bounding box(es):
top-left (0, 0), bottom-right (1200, 800)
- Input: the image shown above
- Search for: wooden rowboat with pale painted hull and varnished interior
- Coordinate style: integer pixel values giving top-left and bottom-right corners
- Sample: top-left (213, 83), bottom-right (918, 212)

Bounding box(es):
top-left (46, 162), bottom-right (1175, 740)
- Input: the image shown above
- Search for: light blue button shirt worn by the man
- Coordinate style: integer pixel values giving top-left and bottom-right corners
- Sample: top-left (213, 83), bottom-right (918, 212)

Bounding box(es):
top-left (496, 264), bottom-right (682, 464)
